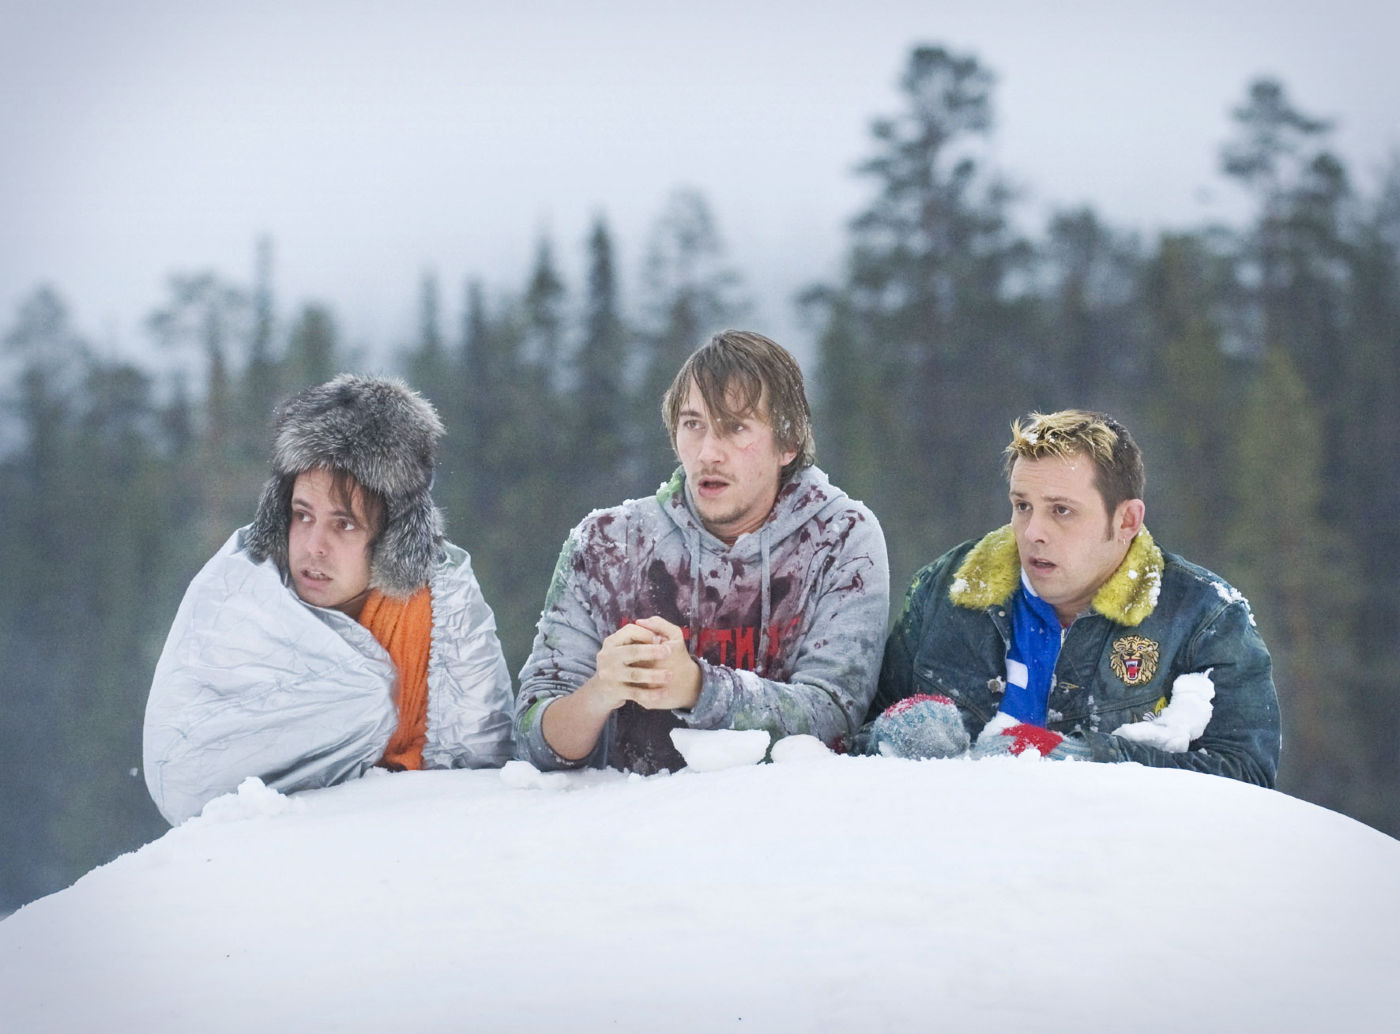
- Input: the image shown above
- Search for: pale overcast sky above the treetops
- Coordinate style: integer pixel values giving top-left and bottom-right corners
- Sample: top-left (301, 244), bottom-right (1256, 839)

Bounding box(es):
top-left (0, 0), bottom-right (1400, 366)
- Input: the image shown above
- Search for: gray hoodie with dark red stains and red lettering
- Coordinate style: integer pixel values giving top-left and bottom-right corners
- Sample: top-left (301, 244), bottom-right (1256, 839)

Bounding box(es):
top-left (515, 467), bottom-right (889, 774)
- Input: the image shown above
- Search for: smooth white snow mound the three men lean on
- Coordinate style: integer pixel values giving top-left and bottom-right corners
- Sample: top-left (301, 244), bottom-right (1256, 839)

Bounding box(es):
top-left (0, 743), bottom-right (1400, 1034)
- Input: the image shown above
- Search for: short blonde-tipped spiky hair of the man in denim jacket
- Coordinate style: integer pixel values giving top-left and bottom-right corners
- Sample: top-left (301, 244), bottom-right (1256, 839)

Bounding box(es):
top-left (1005, 410), bottom-right (1147, 514)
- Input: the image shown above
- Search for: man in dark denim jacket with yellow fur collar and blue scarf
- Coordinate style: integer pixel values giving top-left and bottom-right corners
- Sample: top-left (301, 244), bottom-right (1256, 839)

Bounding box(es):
top-left (861, 410), bottom-right (1280, 786)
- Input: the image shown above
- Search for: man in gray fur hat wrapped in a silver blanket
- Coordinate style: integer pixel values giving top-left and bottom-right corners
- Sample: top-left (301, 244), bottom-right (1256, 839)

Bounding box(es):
top-left (144, 374), bottom-right (512, 823)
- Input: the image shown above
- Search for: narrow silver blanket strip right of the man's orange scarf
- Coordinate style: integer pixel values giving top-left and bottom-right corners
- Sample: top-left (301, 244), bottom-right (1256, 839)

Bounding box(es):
top-left (423, 544), bottom-right (514, 768)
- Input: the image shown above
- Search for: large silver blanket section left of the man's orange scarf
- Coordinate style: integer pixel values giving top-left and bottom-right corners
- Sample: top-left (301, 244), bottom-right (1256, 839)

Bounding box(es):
top-left (143, 534), bottom-right (398, 824)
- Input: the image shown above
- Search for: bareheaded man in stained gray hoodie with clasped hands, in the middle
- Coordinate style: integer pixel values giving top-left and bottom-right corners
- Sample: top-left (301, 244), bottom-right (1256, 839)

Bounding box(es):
top-left (515, 330), bottom-right (889, 774)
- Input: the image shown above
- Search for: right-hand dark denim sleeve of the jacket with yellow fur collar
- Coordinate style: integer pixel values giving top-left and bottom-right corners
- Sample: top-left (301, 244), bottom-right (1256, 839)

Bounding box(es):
top-left (1078, 600), bottom-right (1281, 788)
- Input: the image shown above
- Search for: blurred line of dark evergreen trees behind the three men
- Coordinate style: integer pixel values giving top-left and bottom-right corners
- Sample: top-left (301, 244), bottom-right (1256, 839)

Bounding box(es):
top-left (0, 46), bottom-right (1400, 912)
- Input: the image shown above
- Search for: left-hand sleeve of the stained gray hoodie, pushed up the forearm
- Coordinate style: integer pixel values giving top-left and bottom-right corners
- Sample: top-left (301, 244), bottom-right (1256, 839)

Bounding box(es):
top-left (515, 522), bottom-right (612, 771)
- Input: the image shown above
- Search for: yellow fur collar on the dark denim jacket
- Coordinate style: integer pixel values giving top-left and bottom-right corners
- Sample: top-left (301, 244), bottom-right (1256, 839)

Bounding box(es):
top-left (948, 525), bottom-right (1163, 628)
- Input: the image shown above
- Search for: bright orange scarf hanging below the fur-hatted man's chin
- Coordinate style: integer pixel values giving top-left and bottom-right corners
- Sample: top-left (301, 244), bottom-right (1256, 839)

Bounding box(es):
top-left (360, 588), bottom-right (433, 770)
